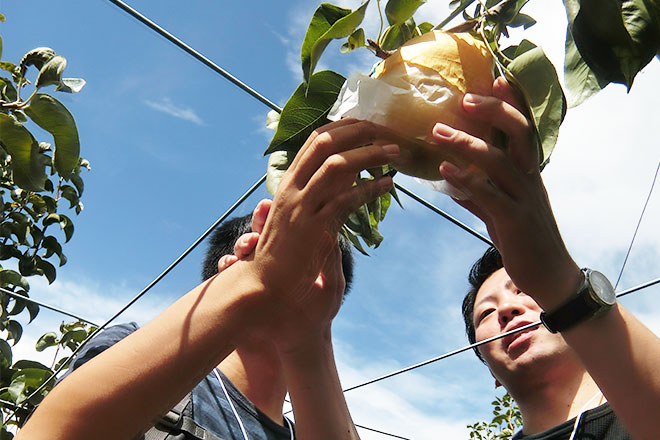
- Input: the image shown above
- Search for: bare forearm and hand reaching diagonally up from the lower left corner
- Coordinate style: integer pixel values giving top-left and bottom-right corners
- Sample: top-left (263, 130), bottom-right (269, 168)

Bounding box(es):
top-left (16, 121), bottom-right (398, 440)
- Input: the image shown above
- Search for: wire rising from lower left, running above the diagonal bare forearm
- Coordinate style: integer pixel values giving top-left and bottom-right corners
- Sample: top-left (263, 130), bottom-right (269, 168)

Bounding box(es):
top-left (10, 174), bottom-right (266, 418)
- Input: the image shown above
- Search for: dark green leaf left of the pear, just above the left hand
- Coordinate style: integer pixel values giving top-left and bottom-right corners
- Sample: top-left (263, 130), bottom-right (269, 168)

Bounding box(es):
top-left (265, 70), bottom-right (346, 154)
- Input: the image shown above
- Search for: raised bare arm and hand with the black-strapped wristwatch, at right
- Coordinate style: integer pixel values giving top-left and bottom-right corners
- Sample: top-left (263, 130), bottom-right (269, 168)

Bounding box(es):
top-left (434, 79), bottom-right (660, 439)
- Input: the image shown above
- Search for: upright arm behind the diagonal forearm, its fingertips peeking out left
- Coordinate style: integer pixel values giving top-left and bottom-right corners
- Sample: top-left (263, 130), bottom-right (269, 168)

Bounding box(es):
top-left (224, 200), bottom-right (359, 440)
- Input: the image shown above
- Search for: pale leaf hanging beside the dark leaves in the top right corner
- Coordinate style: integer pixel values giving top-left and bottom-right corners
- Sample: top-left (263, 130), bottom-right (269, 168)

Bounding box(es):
top-left (564, 27), bottom-right (607, 107)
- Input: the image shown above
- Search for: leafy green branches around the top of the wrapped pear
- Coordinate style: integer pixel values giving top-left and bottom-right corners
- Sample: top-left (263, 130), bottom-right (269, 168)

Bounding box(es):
top-left (266, 0), bottom-right (660, 251)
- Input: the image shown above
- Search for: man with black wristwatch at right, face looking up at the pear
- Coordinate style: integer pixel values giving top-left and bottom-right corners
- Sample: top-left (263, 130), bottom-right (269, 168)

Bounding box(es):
top-left (434, 78), bottom-right (660, 439)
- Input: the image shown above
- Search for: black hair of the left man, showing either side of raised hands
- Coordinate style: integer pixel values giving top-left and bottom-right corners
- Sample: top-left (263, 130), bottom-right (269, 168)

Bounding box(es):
top-left (202, 214), bottom-right (354, 296)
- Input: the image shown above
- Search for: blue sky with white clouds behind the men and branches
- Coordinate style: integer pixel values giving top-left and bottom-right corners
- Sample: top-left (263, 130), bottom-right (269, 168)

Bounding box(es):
top-left (0, 0), bottom-right (660, 439)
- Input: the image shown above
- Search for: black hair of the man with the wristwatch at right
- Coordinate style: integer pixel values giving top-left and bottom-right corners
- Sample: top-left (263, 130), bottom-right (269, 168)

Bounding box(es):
top-left (463, 246), bottom-right (504, 362)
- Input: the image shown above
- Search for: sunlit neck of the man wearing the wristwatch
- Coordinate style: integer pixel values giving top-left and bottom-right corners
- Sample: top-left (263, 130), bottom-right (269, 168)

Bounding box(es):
top-left (510, 370), bottom-right (604, 435)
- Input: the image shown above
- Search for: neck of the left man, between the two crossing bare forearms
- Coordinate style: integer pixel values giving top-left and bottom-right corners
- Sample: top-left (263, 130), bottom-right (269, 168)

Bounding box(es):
top-left (218, 344), bottom-right (286, 425)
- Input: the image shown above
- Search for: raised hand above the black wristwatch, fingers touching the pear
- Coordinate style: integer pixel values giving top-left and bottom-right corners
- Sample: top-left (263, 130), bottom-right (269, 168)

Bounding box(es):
top-left (433, 78), bottom-right (582, 308)
